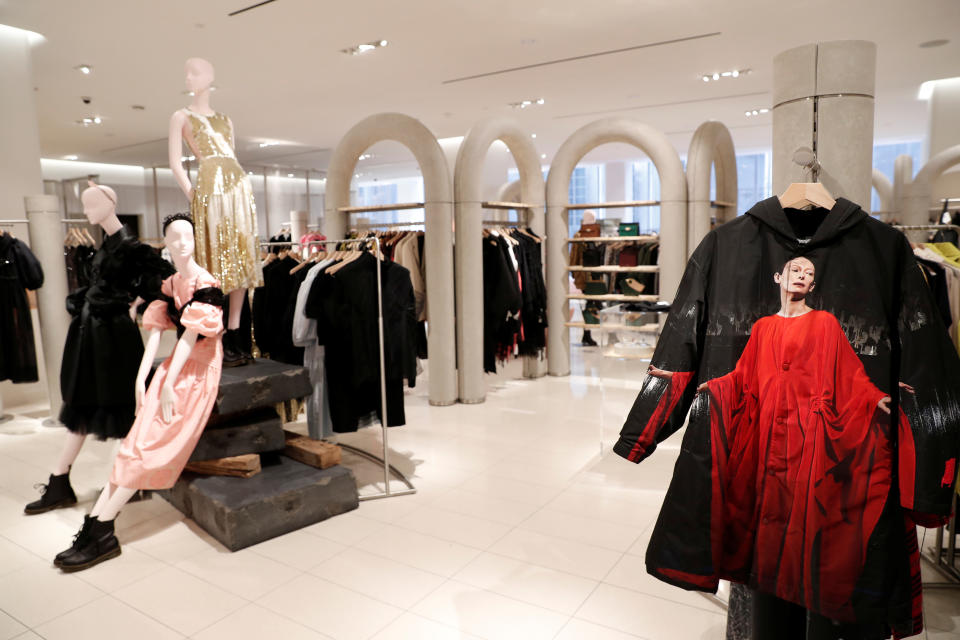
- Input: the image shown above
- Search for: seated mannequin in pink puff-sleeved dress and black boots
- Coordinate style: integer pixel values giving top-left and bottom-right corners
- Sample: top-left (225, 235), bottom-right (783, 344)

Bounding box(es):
top-left (54, 214), bottom-right (223, 572)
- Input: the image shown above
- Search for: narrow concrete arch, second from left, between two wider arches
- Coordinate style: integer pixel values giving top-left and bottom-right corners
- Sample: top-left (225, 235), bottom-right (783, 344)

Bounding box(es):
top-left (453, 118), bottom-right (545, 403)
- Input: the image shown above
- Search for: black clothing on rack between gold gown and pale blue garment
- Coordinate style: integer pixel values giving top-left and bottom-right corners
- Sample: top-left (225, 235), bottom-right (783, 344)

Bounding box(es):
top-left (253, 256), bottom-right (303, 366)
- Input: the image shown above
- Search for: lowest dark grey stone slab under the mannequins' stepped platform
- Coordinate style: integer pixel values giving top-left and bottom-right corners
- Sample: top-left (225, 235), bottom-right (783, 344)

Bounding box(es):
top-left (158, 456), bottom-right (359, 551)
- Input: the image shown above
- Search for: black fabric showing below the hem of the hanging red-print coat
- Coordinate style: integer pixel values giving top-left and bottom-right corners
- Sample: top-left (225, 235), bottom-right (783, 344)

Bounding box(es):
top-left (751, 591), bottom-right (890, 640)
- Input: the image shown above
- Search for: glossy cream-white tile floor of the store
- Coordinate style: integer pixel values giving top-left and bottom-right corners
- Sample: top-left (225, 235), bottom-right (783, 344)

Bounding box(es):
top-left (0, 347), bottom-right (960, 640)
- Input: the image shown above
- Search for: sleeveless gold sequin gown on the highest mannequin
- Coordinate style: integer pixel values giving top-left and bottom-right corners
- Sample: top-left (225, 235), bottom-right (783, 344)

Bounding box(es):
top-left (183, 109), bottom-right (263, 293)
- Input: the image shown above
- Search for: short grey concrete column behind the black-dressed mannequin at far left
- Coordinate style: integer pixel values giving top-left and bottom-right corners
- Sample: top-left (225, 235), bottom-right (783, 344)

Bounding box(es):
top-left (24, 196), bottom-right (70, 418)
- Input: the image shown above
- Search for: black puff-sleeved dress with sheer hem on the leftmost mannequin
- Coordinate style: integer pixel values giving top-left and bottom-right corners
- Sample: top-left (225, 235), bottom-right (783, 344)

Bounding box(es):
top-left (60, 227), bottom-right (175, 440)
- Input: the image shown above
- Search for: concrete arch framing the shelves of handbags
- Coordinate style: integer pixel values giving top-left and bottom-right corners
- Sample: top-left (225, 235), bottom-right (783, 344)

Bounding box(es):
top-left (547, 117), bottom-right (687, 376)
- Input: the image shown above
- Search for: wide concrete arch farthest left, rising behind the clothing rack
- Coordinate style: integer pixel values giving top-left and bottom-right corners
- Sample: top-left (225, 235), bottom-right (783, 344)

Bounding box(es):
top-left (323, 113), bottom-right (457, 405)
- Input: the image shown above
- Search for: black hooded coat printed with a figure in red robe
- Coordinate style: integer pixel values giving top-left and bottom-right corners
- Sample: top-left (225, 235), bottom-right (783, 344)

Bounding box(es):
top-left (614, 198), bottom-right (960, 636)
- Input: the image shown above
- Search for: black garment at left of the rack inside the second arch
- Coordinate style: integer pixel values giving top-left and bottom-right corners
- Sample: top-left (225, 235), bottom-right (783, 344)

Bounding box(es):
top-left (483, 235), bottom-right (523, 373)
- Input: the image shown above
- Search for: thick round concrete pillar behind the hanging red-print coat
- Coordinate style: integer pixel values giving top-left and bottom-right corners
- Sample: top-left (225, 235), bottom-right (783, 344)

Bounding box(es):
top-left (773, 40), bottom-right (877, 209)
